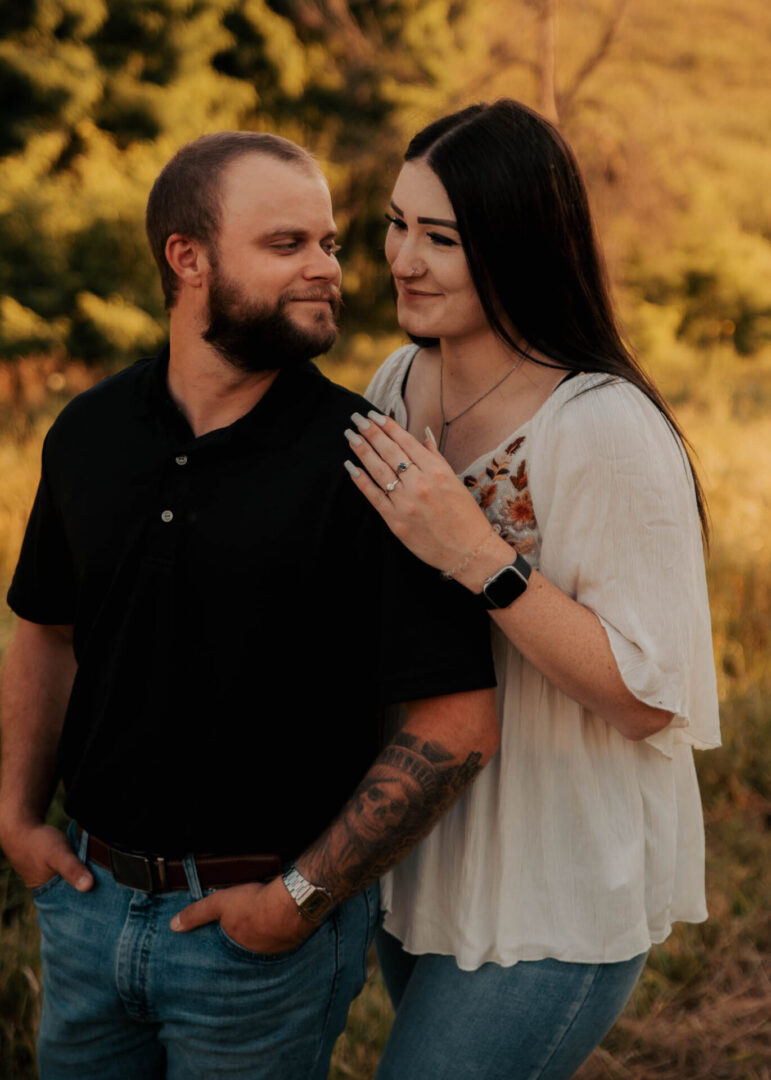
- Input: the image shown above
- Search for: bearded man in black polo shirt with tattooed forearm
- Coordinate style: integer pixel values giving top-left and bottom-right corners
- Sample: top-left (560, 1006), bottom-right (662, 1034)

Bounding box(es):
top-left (0, 133), bottom-right (497, 1080)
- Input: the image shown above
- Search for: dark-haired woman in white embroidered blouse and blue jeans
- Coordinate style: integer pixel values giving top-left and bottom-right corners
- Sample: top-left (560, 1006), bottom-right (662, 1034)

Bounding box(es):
top-left (346, 100), bottom-right (719, 1080)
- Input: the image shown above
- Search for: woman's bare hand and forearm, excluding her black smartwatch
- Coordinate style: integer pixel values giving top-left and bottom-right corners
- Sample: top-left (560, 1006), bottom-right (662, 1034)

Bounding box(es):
top-left (346, 411), bottom-right (672, 740)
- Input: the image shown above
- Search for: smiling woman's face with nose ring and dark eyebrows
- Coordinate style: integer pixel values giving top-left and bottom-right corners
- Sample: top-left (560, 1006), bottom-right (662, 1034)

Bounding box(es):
top-left (386, 159), bottom-right (489, 338)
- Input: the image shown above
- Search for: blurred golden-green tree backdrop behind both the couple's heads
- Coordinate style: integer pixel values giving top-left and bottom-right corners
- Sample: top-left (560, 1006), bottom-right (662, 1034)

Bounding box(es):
top-left (0, 0), bottom-right (771, 380)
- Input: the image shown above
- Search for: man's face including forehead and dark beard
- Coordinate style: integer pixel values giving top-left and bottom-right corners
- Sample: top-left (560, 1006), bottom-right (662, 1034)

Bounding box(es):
top-left (202, 153), bottom-right (340, 370)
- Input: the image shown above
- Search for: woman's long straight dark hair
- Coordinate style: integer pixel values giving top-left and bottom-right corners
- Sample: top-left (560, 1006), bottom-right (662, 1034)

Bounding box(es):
top-left (404, 98), bottom-right (708, 540)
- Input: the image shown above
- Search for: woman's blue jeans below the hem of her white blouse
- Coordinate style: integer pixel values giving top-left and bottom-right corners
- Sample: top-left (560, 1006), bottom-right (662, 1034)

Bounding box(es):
top-left (376, 930), bottom-right (647, 1080)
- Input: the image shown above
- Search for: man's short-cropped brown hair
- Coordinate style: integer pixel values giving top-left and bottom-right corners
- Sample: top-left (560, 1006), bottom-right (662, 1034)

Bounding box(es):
top-left (145, 132), bottom-right (319, 311)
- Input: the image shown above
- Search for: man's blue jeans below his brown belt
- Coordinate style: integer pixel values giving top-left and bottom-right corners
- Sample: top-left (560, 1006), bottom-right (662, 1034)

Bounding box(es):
top-left (33, 820), bottom-right (378, 1080)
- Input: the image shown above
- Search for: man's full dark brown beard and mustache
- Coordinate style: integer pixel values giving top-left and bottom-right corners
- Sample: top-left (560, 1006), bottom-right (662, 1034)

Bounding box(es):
top-left (202, 265), bottom-right (340, 372)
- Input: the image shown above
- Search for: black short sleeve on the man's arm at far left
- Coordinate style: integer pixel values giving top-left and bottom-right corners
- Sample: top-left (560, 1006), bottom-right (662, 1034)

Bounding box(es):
top-left (8, 435), bottom-right (77, 625)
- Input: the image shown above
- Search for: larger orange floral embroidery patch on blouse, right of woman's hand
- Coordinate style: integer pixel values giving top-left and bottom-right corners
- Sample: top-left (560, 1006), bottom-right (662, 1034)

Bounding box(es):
top-left (463, 435), bottom-right (538, 555)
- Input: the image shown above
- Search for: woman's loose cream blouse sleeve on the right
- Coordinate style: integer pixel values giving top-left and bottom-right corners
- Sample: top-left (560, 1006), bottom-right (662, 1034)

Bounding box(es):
top-left (530, 377), bottom-right (719, 755)
